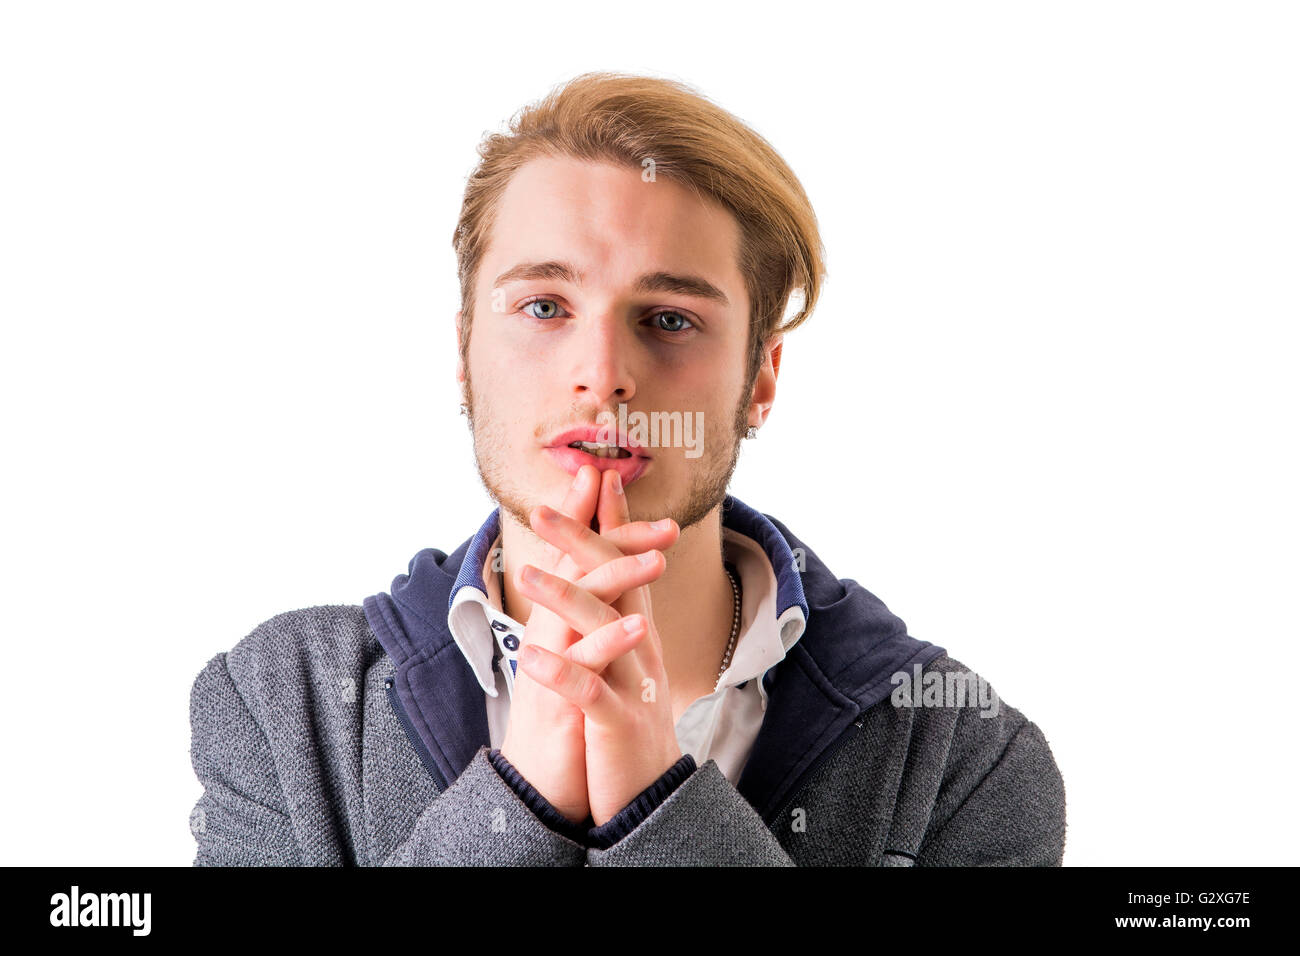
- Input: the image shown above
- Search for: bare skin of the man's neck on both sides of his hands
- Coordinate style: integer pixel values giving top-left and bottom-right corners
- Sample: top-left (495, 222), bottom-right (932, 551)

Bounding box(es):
top-left (501, 505), bottom-right (733, 715)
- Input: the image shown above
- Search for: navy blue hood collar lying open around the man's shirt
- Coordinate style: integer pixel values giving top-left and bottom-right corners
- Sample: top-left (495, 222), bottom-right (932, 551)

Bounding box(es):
top-left (364, 496), bottom-right (944, 817)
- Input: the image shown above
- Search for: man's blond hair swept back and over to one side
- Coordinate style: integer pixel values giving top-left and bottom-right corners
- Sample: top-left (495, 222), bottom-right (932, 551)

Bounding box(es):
top-left (452, 73), bottom-right (826, 388)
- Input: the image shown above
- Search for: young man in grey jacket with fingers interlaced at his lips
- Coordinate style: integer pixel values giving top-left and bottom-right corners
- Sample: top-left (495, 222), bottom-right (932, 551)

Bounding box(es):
top-left (191, 74), bottom-right (1065, 866)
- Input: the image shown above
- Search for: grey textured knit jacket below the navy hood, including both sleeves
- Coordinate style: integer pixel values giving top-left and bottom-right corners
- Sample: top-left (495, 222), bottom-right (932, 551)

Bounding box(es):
top-left (190, 605), bottom-right (1065, 866)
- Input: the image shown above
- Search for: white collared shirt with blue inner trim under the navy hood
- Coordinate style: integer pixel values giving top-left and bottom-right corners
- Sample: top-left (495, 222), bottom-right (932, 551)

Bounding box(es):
top-left (447, 527), bottom-right (806, 784)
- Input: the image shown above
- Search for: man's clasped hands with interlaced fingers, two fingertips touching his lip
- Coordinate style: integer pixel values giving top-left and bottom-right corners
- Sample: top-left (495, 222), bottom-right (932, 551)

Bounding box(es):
top-left (501, 464), bottom-right (681, 826)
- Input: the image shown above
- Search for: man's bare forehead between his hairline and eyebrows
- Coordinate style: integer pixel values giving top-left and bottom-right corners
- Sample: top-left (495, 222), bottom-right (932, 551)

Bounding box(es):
top-left (480, 156), bottom-right (744, 302)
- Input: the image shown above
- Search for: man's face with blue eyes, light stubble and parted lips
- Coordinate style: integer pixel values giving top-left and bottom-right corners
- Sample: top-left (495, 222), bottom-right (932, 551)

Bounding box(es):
top-left (458, 157), bottom-right (761, 531)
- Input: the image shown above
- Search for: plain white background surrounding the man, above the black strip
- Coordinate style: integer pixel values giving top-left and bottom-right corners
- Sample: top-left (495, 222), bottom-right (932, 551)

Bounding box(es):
top-left (0, 0), bottom-right (1300, 865)
